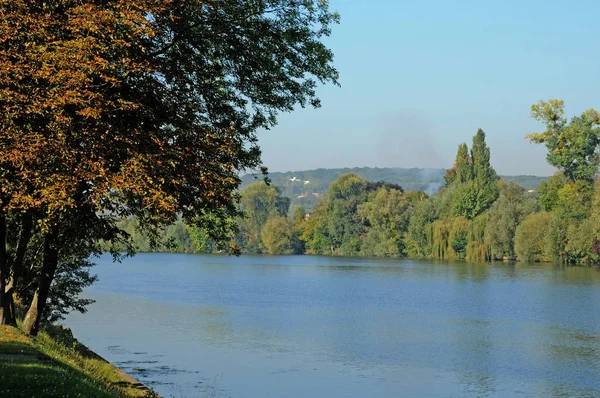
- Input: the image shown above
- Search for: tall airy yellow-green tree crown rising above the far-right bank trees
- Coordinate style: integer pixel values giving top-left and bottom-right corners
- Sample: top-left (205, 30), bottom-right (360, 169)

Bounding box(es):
top-left (525, 99), bottom-right (600, 182)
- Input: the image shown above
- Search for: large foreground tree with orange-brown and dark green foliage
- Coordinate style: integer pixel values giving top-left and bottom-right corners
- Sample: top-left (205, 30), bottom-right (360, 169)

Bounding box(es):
top-left (0, 0), bottom-right (338, 334)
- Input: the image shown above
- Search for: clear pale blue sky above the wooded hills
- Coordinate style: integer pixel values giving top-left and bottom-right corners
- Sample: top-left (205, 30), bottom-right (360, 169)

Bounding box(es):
top-left (254, 0), bottom-right (600, 176)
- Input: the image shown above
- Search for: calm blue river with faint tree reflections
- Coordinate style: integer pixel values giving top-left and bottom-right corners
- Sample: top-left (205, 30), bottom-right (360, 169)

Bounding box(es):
top-left (65, 254), bottom-right (600, 398)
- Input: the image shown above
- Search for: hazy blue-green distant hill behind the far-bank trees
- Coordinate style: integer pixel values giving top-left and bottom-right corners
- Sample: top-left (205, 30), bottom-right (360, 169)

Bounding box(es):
top-left (242, 167), bottom-right (547, 209)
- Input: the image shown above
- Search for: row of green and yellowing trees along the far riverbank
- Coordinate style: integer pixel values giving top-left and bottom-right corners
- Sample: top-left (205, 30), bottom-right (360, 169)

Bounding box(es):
top-left (138, 100), bottom-right (600, 264)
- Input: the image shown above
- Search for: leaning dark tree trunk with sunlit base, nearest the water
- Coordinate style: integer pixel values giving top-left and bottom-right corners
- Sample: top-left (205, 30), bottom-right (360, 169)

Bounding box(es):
top-left (21, 231), bottom-right (58, 336)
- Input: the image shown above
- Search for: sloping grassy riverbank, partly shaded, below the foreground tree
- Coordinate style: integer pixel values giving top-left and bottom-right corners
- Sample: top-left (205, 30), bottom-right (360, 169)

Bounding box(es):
top-left (0, 326), bottom-right (158, 398)
